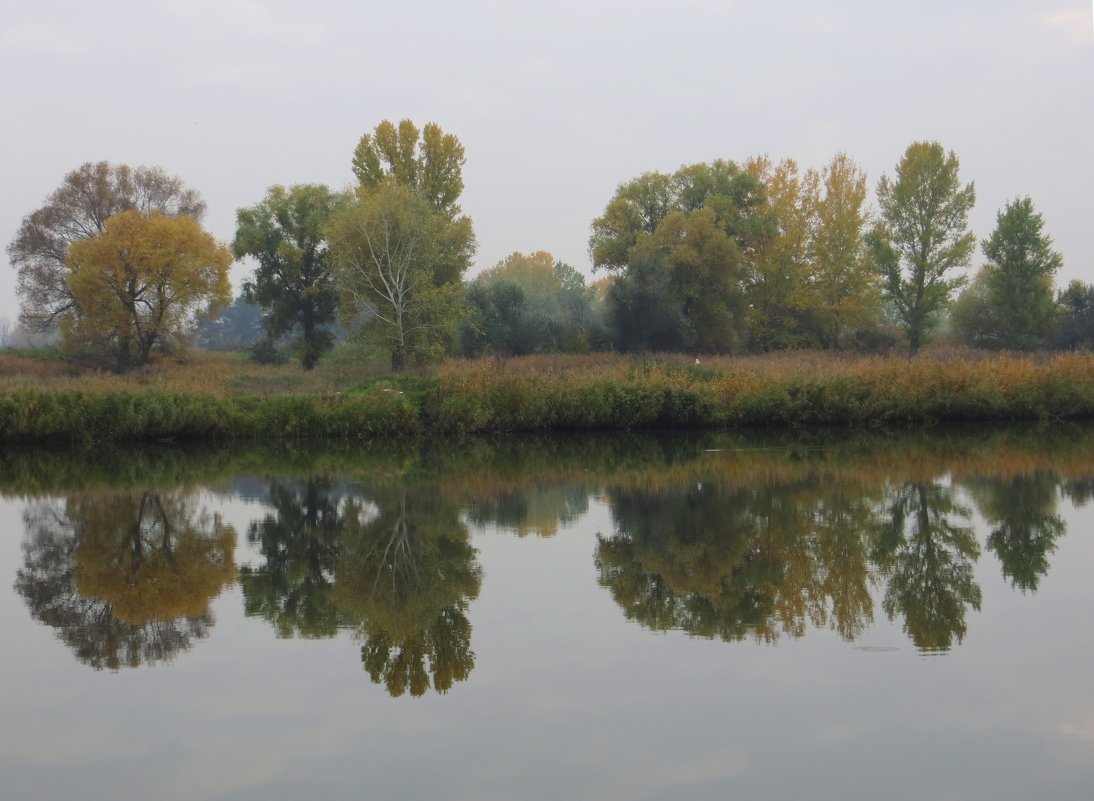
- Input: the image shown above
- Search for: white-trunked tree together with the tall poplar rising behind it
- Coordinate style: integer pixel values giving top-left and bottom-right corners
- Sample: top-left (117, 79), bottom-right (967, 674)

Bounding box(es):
top-left (328, 119), bottom-right (475, 370)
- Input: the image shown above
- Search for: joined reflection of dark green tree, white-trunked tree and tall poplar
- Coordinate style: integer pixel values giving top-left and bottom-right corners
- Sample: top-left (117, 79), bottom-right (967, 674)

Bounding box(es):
top-left (240, 478), bottom-right (482, 696)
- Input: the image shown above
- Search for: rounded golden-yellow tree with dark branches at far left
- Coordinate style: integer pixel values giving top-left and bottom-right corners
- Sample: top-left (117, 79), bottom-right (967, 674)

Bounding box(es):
top-left (61, 211), bottom-right (232, 369)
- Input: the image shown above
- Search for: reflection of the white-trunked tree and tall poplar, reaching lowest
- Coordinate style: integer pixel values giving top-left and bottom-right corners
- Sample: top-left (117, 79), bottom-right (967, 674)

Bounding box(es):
top-left (335, 487), bottom-right (482, 696)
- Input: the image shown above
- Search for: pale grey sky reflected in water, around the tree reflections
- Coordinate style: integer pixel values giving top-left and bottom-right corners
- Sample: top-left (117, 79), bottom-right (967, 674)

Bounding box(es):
top-left (0, 468), bottom-right (1094, 801)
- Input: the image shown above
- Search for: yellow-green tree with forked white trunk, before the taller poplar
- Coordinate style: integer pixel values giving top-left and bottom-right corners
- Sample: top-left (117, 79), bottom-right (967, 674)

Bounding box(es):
top-left (328, 184), bottom-right (475, 371)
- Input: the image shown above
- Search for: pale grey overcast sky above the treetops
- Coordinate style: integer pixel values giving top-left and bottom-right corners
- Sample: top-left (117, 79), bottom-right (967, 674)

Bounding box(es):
top-left (0, 0), bottom-right (1094, 330)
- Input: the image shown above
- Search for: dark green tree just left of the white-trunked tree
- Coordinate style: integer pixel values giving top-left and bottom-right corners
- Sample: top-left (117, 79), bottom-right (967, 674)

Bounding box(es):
top-left (232, 184), bottom-right (339, 370)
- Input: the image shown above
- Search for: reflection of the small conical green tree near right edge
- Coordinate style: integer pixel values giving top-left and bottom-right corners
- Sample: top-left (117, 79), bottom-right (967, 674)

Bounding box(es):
top-left (971, 471), bottom-right (1067, 592)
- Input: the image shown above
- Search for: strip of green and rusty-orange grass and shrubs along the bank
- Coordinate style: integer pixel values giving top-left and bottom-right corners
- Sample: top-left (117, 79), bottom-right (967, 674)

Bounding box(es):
top-left (0, 349), bottom-right (1094, 443)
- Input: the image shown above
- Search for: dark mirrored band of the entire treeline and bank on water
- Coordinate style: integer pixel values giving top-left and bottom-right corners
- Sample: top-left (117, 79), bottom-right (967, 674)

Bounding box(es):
top-left (6, 428), bottom-right (1094, 696)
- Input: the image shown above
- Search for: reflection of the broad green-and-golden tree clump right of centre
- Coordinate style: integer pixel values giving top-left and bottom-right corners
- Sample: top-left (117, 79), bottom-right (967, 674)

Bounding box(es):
top-left (596, 476), bottom-right (873, 641)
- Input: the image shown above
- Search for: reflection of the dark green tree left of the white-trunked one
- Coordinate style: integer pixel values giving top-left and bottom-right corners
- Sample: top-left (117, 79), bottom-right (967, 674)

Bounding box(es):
top-left (240, 478), bottom-right (350, 637)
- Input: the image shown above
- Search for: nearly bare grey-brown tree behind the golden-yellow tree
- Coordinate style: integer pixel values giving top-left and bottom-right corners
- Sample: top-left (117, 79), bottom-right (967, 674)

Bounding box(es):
top-left (8, 161), bottom-right (206, 332)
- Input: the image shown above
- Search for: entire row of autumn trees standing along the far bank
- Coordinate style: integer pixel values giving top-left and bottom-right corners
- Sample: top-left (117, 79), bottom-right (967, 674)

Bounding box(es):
top-left (8, 120), bottom-right (1094, 370)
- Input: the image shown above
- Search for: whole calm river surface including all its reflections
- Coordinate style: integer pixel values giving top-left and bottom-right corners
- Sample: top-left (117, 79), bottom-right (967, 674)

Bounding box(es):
top-left (0, 426), bottom-right (1094, 801)
